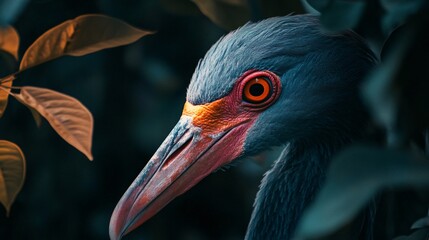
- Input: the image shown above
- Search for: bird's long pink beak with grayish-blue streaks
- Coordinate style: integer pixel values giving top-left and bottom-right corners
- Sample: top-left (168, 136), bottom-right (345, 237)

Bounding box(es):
top-left (109, 100), bottom-right (253, 240)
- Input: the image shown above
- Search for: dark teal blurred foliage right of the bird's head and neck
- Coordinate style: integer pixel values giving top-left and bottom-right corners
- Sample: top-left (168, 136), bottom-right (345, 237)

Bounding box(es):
top-left (297, 0), bottom-right (429, 240)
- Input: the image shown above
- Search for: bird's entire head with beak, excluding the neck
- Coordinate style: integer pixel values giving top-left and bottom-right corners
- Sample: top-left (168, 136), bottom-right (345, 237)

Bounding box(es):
top-left (110, 15), bottom-right (374, 239)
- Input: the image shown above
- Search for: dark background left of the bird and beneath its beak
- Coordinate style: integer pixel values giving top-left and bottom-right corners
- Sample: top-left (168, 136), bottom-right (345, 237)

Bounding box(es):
top-left (0, 0), bottom-right (270, 239)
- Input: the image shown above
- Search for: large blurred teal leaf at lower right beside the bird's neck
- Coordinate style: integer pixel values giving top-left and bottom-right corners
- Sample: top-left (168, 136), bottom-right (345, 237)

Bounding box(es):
top-left (297, 145), bottom-right (429, 239)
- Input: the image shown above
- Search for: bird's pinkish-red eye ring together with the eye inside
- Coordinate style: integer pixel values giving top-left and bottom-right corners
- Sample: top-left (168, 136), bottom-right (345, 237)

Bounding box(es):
top-left (237, 70), bottom-right (281, 111)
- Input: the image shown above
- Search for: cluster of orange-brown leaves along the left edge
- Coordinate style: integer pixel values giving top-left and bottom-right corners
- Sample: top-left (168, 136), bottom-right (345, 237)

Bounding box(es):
top-left (0, 14), bottom-right (151, 218)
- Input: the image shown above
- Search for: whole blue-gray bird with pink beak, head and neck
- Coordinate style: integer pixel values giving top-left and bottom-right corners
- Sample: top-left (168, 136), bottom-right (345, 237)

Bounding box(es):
top-left (109, 14), bottom-right (378, 240)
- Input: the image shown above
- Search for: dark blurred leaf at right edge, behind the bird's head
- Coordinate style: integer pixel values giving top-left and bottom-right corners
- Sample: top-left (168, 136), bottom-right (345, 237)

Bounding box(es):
top-left (363, 14), bottom-right (429, 145)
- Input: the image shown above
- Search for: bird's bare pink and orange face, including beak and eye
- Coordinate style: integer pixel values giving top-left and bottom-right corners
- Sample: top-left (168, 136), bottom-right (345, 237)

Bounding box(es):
top-left (110, 70), bottom-right (281, 239)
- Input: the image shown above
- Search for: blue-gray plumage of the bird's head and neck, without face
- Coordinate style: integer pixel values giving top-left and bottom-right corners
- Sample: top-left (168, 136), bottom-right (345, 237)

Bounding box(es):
top-left (187, 15), bottom-right (377, 239)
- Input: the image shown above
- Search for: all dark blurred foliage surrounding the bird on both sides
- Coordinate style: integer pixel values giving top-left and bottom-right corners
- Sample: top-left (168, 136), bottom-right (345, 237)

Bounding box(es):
top-left (0, 0), bottom-right (429, 240)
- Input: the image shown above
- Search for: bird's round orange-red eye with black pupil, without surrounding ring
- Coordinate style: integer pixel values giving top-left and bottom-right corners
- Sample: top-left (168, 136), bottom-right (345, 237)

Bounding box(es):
top-left (243, 77), bottom-right (272, 103)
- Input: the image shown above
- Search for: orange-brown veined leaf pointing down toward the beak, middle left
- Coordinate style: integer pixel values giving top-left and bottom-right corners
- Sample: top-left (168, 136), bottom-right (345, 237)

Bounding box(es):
top-left (13, 86), bottom-right (94, 160)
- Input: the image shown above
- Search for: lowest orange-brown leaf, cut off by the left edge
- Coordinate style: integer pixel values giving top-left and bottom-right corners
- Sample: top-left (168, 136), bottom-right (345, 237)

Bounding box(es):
top-left (0, 140), bottom-right (25, 215)
